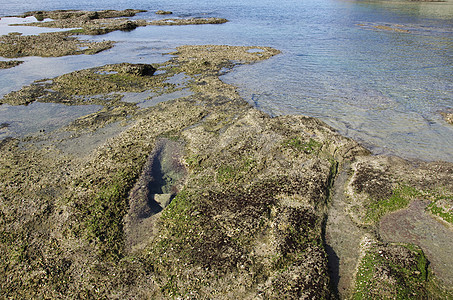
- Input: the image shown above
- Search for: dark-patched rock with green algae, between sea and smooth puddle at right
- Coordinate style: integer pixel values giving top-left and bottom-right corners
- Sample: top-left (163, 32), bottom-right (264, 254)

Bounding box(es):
top-left (347, 157), bottom-right (453, 226)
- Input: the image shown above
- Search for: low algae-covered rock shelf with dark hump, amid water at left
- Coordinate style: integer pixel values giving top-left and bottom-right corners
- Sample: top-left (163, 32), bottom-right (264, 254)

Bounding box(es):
top-left (0, 63), bottom-right (161, 105)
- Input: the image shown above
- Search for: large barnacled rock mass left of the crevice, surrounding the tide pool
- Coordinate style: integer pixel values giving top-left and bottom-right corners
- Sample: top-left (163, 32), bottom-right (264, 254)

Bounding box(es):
top-left (1, 46), bottom-right (356, 298)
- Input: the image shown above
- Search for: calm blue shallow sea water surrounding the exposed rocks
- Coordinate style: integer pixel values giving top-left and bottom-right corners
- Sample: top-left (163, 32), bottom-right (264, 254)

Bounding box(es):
top-left (0, 0), bottom-right (453, 161)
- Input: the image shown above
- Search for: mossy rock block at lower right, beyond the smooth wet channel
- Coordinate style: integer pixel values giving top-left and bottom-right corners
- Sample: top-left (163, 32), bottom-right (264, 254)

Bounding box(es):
top-left (334, 156), bottom-right (453, 299)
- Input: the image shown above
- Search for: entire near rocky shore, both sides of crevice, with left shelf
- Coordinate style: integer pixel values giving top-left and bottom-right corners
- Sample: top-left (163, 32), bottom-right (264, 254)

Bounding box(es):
top-left (0, 8), bottom-right (453, 299)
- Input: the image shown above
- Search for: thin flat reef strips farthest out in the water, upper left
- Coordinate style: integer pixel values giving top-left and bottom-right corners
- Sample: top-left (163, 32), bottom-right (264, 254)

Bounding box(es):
top-left (0, 9), bottom-right (227, 60)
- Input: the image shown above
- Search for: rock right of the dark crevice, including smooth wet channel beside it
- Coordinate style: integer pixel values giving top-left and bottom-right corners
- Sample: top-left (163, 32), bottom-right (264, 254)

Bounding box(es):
top-left (326, 156), bottom-right (453, 299)
